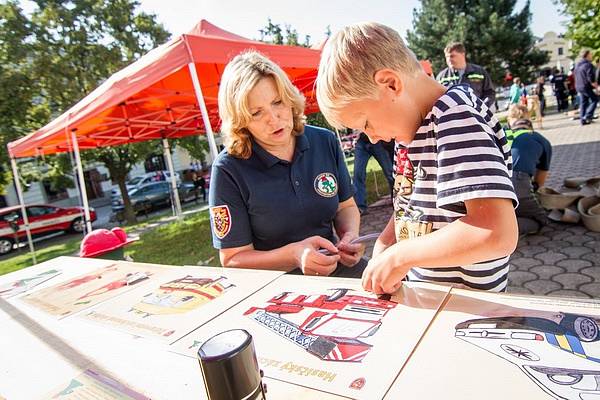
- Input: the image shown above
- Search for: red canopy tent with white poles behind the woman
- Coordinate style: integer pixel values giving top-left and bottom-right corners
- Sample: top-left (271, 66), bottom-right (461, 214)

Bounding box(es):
top-left (8, 20), bottom-right (320, 263)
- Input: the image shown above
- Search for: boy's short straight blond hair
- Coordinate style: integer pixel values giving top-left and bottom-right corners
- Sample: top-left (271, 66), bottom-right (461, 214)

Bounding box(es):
top-left (317, 22), bottom-right (422, 129)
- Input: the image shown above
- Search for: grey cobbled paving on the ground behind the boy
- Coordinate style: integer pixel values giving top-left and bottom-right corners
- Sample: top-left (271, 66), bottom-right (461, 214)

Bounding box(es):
top-left (361, 108), bottom-right (600, 298)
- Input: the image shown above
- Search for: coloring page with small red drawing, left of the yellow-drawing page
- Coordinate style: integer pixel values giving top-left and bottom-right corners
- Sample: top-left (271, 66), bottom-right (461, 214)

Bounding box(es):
top-left (21, 262), bottom-right (170, 318)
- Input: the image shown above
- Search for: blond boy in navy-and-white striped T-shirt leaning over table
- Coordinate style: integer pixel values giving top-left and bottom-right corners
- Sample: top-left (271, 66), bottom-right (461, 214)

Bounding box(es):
top-left (317, 23), bottom-right (518, 293)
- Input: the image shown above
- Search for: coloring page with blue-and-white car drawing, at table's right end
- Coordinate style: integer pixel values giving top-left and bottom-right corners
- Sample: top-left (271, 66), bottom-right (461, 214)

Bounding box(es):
top-left (387, 289), bottom-right (600, 400)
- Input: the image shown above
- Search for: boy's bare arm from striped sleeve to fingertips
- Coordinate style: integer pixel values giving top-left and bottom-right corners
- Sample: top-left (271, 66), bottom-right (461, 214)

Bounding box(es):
top-left (362, 198), bottom-right (518, 294)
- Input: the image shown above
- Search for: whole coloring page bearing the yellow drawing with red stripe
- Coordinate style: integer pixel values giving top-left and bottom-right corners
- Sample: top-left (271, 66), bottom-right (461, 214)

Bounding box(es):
top-left (78, 267), bottom-right (283, 343)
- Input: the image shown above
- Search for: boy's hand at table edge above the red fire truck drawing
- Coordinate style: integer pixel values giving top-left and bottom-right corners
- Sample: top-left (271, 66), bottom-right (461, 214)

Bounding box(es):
top-left (362, 251), bottom-right (408, 294)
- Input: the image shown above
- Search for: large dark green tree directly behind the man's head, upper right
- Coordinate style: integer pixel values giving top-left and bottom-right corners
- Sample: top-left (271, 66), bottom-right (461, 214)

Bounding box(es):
top-left (407, 0), bottom-right (548, 84)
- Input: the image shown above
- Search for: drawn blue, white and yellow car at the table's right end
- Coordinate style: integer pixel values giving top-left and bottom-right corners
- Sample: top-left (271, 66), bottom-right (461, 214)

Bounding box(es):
top-left (455, 312), bottom-right (600, 400)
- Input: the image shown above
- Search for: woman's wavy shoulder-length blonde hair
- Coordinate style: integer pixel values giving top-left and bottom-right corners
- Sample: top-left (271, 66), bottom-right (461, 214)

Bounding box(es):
top-left (219, 51), bottom-right (305, 159)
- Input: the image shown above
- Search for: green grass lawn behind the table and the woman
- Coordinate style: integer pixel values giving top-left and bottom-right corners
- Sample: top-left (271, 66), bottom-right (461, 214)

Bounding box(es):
top-left (0, 158), bottom-right (389, 275)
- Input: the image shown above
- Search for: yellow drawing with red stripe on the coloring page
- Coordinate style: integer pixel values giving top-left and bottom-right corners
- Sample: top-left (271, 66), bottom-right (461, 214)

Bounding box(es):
top-left (129, 275), bottom-right (235, 318)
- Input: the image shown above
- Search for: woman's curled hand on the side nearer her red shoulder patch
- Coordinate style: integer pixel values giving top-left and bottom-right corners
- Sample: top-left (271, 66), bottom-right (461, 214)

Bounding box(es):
top-left (290, 236), bottom-right (340, 276)
